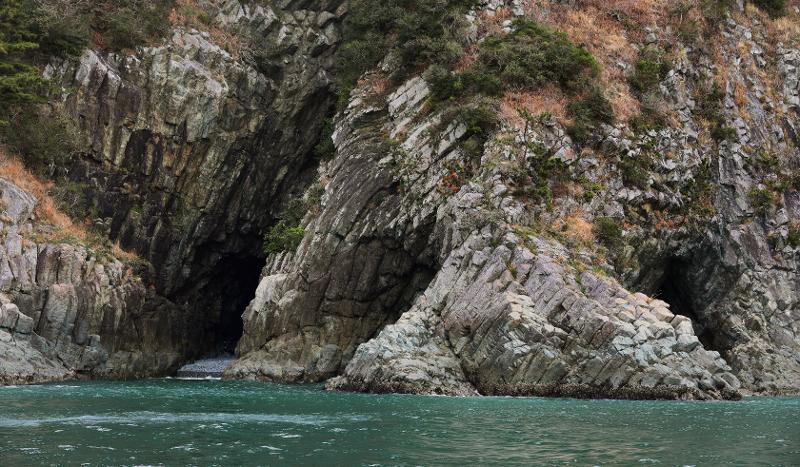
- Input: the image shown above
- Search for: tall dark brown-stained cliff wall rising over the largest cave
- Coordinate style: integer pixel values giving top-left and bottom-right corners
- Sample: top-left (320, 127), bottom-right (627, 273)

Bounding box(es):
top-left (46, 0), bottom-right (338, 352)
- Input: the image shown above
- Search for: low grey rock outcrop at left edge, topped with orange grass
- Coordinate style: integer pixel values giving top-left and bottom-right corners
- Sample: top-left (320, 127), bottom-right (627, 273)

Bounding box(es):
top-left (0, 179), bottom-right (188, 384)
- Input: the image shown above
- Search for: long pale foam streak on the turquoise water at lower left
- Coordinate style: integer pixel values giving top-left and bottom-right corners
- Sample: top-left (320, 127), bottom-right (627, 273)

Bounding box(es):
top-left (0, 412), bottom-right (368, 429)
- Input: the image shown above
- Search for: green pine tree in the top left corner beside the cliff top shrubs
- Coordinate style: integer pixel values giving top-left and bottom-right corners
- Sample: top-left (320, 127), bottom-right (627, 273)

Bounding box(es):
top-left (0, 0), bottom-right (44, 126)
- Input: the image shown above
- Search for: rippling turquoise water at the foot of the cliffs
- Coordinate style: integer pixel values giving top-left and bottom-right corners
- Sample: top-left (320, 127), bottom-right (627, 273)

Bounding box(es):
top-left (0, 380), bottom-right (800, 466)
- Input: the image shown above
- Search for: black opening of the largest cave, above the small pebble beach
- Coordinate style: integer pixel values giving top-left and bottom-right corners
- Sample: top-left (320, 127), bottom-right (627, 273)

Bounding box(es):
top-left (202, 255), bottom-right (264, 357)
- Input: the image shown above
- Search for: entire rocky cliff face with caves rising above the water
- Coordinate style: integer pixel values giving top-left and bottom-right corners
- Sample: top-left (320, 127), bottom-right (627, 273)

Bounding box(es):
top-left (0, 0), bottom-right (800, 399)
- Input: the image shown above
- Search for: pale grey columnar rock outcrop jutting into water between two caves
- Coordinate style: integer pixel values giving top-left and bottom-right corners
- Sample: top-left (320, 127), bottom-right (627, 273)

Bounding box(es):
top-left (229, 75), bottom-right (739, 397)
